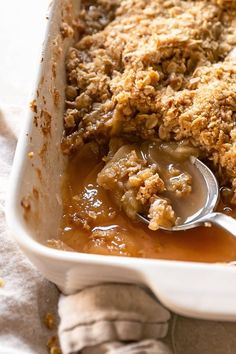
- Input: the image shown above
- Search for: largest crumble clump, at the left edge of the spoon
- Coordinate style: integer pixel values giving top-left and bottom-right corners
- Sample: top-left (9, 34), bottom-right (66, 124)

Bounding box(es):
top-left (97, 145), bottom-right (168, 219)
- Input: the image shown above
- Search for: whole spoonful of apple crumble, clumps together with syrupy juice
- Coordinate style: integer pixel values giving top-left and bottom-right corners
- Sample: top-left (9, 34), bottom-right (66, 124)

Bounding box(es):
top-left (97, 139), bottom-right (206, 230)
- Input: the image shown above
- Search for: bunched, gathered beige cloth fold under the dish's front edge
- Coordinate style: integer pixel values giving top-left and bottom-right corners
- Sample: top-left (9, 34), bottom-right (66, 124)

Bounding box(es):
top-left (59, 284), bottom-right (170, 354)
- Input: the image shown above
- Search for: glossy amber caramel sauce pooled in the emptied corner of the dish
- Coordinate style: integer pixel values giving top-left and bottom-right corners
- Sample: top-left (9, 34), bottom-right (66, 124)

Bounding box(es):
top-left (60, 150), bottom-right (236, 262)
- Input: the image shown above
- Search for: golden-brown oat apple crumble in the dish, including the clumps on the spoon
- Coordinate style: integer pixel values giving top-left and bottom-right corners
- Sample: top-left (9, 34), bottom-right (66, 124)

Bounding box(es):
top-left (62, 0), bottom-right (236, 239)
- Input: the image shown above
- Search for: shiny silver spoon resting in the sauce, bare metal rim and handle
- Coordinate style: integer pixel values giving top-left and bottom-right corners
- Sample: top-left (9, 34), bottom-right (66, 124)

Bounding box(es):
top-left (137, 156), bottom-right (236, 236)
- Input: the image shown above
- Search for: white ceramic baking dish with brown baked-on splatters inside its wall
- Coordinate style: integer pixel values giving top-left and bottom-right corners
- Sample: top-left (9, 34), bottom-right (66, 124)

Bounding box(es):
top-left (7, 0), bottom-right (236, 320)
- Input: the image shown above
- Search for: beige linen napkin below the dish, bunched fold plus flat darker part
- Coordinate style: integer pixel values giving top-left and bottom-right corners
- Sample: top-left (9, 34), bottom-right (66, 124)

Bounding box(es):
top-left (59, 280), bottom-right (236, 354)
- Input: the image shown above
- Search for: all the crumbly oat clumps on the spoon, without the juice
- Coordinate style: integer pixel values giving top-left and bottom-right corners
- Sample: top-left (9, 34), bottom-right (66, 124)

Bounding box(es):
top-left (97, 145), bottom-right (192, 230)
